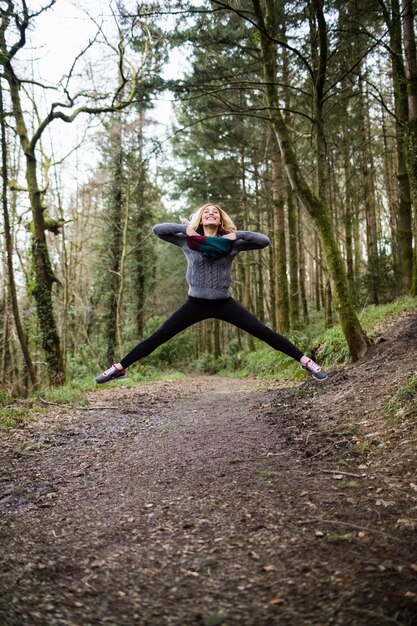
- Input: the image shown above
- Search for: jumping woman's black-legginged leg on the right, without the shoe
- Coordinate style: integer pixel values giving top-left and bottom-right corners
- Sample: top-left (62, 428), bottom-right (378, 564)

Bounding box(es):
top-left (216, 298), bottom-right (304, 361)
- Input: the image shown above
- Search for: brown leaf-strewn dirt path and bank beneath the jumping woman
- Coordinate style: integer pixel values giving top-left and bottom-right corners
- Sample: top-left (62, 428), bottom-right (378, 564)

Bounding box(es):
top-left (0, 314), bottom-right (417, 626)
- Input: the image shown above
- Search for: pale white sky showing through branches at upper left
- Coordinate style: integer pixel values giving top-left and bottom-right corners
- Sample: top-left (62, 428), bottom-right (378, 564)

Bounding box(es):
top-left (12, 0), bottom-right (178, 193)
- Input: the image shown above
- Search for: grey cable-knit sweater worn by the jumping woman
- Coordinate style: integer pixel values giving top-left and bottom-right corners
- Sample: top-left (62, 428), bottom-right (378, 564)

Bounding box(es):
top-left (153, 223), bottom-right (270, 300)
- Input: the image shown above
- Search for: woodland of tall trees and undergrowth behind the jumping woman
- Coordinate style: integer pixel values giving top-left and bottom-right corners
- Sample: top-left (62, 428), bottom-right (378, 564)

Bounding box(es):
top-left (0, 0), bottom-right (417, 396)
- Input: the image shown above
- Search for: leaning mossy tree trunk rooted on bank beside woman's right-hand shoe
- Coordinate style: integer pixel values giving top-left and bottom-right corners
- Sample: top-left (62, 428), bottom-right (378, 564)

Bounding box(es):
top-left (252, 0), bottom-right (369, 360)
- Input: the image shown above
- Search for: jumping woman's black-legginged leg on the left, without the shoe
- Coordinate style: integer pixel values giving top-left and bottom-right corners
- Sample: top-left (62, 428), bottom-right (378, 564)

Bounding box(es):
top-left (120, 298), bottom-right (207, 368)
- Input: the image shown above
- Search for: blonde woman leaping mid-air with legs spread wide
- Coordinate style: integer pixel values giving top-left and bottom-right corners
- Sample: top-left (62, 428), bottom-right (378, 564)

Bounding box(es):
top-left (96, 204), bottom-right (327, 384)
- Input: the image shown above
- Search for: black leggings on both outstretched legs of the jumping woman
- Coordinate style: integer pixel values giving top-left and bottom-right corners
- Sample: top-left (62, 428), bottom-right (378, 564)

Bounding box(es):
top-left (120, 296), bottom-right (303, 367)
